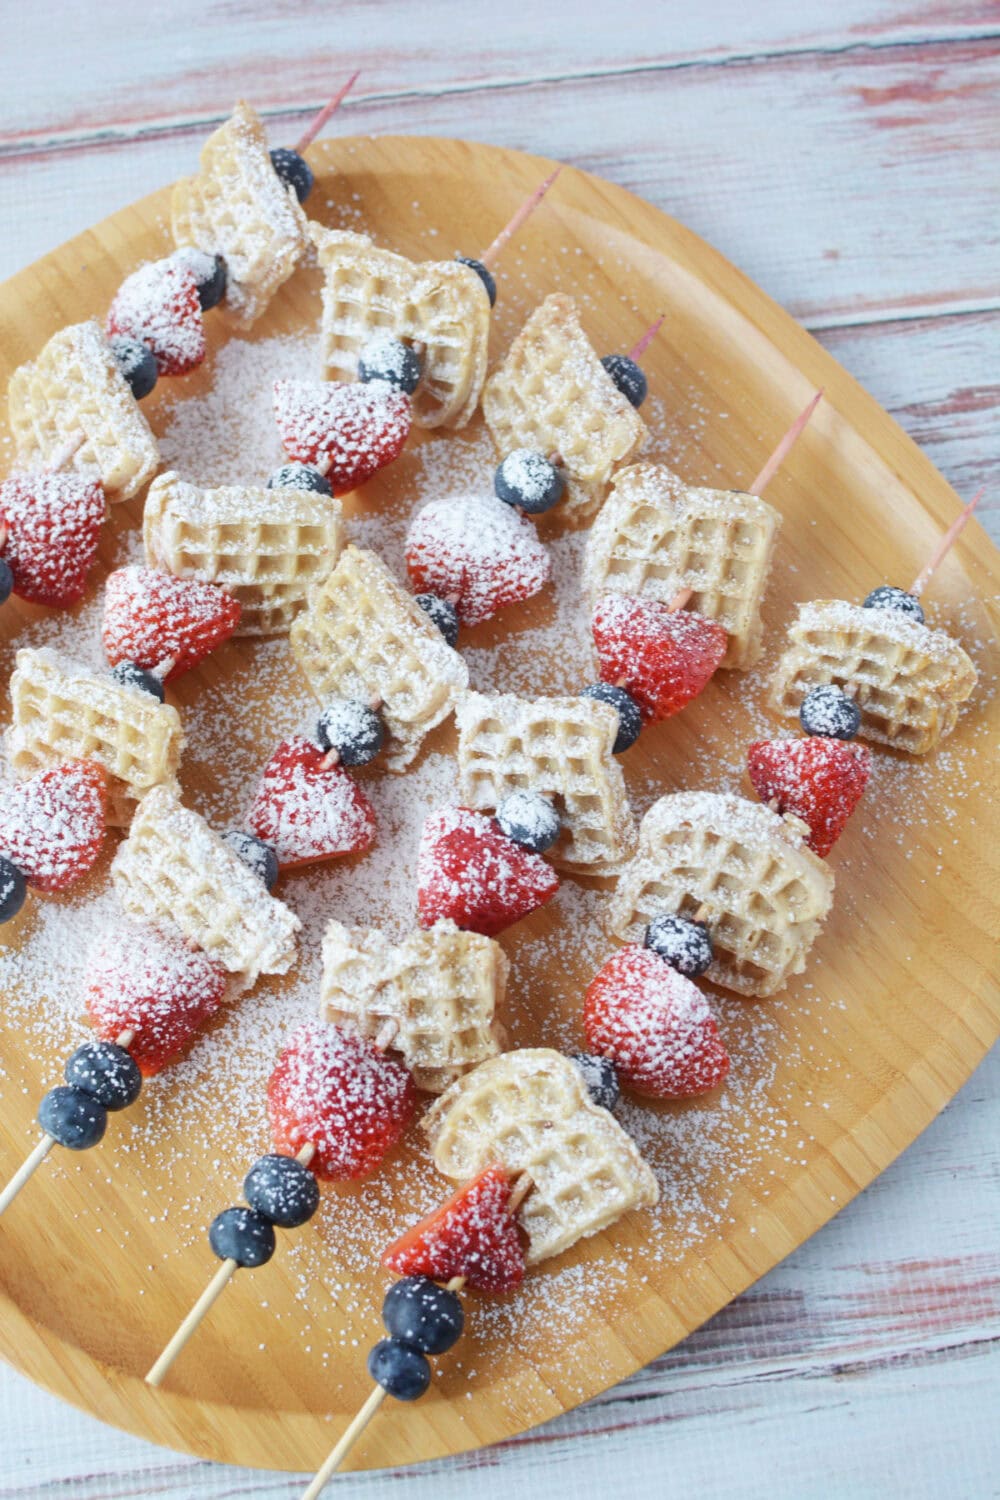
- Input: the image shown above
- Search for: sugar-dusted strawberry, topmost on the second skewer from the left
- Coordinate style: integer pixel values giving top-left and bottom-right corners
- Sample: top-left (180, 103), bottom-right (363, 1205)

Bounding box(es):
top-left (274, 380), bottom-right (412, 495)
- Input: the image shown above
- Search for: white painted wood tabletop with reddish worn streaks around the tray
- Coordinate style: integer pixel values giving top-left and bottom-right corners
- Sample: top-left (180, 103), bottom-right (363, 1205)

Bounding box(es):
top-left (0, 0), bottom-right (1000, 1500)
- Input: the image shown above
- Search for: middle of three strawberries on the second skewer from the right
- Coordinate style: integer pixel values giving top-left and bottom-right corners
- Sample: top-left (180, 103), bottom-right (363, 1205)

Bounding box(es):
top-left (417, 807), bottom-right (559, 938)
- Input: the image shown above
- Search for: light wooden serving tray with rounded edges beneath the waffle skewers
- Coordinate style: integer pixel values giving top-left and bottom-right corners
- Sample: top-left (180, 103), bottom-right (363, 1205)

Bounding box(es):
top-left (0, 138), bottom-right (1000, 1470)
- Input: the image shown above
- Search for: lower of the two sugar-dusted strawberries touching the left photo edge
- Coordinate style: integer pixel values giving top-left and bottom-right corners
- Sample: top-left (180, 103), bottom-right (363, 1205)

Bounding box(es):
top-left (0, 761), bottom-right (108, 891)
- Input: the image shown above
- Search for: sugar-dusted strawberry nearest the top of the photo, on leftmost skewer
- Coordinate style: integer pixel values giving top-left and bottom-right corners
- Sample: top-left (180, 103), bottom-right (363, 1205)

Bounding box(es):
top-left (108, 257), bottom-right (205, 375)
